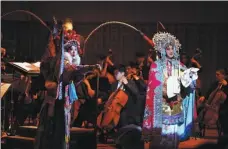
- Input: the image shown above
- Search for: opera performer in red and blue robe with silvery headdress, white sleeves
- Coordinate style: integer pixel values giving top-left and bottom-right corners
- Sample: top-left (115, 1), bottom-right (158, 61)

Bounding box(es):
top-left (143, 33), bottom-right (198, 149)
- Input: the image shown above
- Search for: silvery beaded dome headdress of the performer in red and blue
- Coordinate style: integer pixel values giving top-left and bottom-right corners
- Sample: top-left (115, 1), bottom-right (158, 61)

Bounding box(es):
top-left (152, 32), bottom-right (181, 58)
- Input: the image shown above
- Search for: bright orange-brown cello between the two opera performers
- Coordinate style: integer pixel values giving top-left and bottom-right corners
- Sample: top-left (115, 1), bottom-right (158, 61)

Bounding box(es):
top-left (97, 84), bottom-right (128, 129)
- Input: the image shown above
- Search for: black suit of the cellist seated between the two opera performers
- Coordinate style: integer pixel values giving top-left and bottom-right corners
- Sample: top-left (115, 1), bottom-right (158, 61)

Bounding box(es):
top-left (111, 80), bottom-right (138, 127)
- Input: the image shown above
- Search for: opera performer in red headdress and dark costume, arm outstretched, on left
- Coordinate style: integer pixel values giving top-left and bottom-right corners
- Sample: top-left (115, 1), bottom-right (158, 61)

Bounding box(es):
top-left (35, 19), bottom-right (83, 149)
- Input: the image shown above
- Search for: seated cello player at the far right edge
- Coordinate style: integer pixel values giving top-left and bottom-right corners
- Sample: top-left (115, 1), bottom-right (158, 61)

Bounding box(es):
top-left (199, 69), bottom-right (228, 134)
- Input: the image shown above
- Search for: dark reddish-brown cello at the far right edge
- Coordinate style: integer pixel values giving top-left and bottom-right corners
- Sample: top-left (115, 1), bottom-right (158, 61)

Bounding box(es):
top-left (198, 84), bottom-right (226, 126)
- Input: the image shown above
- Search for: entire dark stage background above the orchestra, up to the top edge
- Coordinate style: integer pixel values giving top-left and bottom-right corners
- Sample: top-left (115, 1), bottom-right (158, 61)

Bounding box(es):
top-left (1, 2), bottom-right (228, 94)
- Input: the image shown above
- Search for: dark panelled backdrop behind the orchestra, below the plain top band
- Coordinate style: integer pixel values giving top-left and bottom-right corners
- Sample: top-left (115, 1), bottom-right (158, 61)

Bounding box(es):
top-left (1, 20), bottom-right (228, 92)
